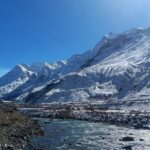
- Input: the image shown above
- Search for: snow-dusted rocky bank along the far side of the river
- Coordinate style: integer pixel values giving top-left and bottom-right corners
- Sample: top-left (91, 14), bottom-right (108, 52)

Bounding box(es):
top-left (20, 103), bottom-right (150, 129)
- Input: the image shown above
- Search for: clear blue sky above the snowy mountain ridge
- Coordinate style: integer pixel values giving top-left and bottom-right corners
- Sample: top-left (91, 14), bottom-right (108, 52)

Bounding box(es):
top-left (0, 0), bottom-right (150, 75)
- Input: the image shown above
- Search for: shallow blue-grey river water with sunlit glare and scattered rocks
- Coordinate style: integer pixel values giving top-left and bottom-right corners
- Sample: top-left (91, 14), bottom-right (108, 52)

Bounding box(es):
top-left (25, 119), bottom-right (150, 150)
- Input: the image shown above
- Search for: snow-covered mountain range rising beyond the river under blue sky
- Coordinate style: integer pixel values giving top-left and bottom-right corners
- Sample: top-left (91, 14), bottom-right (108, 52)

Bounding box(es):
top-left (0, 28), bottom-right (150, 103)
